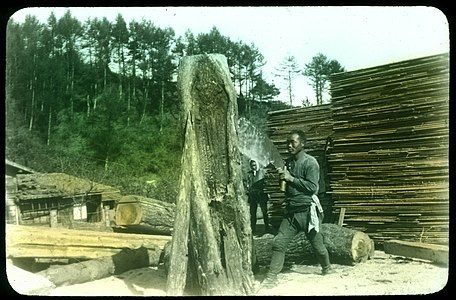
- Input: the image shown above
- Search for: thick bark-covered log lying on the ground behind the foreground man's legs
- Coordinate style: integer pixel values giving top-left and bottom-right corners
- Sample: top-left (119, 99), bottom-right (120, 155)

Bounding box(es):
top-left (254, 223), bottom-right (375, 265)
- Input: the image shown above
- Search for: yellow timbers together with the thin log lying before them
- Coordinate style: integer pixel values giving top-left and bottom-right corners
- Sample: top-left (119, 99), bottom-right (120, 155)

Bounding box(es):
top-left (5, 224), bottom-right (171, 286)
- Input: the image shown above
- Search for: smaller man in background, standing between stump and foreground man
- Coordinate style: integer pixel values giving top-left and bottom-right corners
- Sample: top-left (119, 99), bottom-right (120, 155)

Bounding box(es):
top-left (247, 159), bottom-right (269, 234)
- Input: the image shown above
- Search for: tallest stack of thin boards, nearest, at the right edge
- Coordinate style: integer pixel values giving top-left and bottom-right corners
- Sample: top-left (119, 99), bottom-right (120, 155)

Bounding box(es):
top-left (328, 54), bottom-right (449, 244)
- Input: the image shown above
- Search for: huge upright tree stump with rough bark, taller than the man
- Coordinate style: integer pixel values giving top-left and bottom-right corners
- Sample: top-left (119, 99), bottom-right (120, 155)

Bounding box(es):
top-left (167, 54), bottom-right (253, 295)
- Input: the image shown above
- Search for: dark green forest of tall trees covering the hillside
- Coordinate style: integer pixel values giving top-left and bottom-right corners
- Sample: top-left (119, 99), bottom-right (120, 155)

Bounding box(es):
top-left (5, 10), bottom-right (344, 201)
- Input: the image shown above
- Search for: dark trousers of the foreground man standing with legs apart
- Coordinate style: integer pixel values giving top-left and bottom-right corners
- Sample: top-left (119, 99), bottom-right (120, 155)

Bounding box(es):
top-left (268, 209), bottom-right (330, 276)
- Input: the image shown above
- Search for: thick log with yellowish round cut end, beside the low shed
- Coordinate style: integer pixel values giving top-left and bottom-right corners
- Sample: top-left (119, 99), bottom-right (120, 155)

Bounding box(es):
top-left (115, 195), bottom-right (176, 235)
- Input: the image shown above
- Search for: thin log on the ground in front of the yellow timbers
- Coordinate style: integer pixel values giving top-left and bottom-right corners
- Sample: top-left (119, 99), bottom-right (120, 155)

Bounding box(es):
top-left (36, 247), bottom-right (153, 286)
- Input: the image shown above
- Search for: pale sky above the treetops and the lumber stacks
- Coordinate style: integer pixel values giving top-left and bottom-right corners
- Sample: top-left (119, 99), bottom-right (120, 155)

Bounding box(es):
top-left (8, 6), bottom-right (450, 106)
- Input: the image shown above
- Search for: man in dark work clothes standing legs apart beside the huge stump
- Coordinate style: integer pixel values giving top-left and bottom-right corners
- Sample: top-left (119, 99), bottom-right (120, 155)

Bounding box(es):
top-left (262, 130), bottom-right (332, 288)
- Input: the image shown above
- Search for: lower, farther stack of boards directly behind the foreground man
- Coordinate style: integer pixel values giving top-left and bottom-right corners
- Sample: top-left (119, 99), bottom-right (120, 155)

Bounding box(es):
top-left (265, 104), bottom-right (332, 226)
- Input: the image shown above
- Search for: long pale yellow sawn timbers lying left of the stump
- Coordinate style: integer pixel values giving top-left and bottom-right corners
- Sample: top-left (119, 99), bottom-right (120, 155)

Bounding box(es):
top-left (5, 224), bottom-right (171, 264)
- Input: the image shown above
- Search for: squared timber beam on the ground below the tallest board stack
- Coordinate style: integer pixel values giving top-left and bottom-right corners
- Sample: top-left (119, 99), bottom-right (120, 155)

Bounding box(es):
top-left (383, 240), bottom-right (448, 265)
